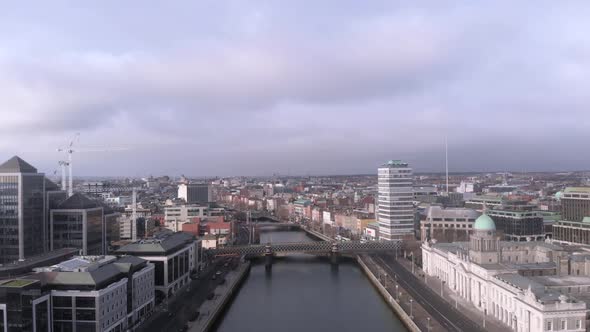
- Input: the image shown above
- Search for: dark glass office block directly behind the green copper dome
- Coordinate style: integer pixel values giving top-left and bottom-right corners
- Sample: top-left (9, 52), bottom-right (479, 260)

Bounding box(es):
top-left (488, 203), bottom-right (545, 242)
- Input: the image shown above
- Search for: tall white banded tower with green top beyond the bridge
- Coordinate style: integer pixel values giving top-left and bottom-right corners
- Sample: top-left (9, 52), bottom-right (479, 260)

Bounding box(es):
top-left (378, 160), bottom-right (414, 240)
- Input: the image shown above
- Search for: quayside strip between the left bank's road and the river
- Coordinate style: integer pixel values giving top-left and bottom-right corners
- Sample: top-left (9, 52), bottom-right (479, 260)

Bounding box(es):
top-left (189, 261), bottom-right (251, 332)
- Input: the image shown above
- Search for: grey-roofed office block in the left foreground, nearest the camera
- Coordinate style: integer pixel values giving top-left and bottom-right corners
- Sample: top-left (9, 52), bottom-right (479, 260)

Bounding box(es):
top-left (29, 256), bottom-right (155, 332)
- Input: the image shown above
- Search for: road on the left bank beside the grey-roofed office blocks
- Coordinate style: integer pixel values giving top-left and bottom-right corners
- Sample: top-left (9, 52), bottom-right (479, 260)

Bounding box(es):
top-left (138, 258), bottom-right (239, 332)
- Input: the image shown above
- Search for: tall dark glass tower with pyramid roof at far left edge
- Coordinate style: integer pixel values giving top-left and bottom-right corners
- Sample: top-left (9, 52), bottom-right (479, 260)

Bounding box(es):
top-left (0, 156), bottom-right (48, 263)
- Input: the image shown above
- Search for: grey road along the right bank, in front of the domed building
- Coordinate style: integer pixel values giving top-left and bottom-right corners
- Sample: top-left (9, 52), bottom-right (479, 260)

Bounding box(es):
top-left (371, 255), bottom-right (485, 332)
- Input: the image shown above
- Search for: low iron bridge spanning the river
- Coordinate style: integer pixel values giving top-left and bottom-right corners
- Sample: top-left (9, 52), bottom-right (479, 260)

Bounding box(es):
top-left (207, 241), bottom-right (402, 256)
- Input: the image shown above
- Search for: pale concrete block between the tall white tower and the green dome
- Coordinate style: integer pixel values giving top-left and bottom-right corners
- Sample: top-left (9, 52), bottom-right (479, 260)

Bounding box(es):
top-left (420, 205), bottom-right (481, 242)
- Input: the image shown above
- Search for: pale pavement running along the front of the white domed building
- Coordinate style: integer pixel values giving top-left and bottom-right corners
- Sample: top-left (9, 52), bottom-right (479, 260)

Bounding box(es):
top-left (398, 255), bottom-right (510, 332)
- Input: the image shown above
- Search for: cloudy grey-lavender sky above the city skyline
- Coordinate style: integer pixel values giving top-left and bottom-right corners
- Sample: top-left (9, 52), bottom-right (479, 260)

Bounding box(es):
top-left (0, 0), bottom-right (590, 176)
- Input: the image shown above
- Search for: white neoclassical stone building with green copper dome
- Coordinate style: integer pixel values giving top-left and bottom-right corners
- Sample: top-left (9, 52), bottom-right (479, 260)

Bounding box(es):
top-left (422, 214), bottom-right (590, 331)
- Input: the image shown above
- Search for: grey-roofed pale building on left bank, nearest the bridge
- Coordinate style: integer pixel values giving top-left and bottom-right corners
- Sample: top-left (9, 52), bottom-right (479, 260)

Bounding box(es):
top-left (117, 232), bottom-right (201, 298)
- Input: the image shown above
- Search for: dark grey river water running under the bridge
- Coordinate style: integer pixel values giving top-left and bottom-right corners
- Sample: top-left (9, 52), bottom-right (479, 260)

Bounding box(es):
top-left (217, 232), bottom-right (407, 332)
